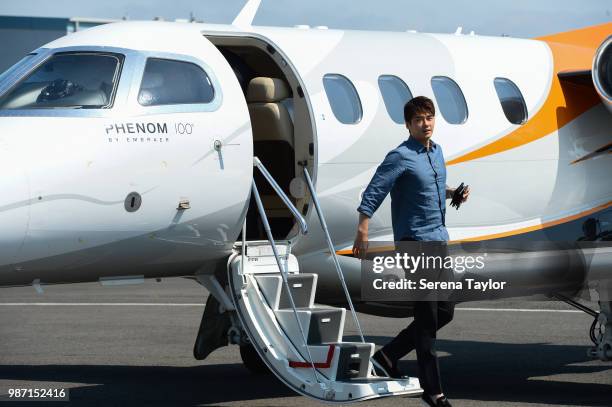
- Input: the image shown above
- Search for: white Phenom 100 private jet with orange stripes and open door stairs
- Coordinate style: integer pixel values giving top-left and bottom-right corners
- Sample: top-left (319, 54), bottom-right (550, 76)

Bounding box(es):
top-left (0, 1), bottom-right (612, 403)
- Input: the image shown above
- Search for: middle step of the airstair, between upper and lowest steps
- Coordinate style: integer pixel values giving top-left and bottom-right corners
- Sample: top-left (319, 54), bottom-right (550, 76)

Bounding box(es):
top-left (274, 307), bottom-right (346, 346)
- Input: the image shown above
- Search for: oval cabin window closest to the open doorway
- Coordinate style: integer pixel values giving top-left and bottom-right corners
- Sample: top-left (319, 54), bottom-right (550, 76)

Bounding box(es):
top-left (323, 74), bottom-right (363, 124)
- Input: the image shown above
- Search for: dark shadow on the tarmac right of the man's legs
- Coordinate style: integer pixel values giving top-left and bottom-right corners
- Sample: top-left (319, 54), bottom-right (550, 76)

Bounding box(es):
top-left (345, 336), bottom-right (612, 406)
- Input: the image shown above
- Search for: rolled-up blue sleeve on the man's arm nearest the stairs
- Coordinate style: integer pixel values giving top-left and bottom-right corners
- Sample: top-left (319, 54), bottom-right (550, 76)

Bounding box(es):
top-left (357, 150), bottom-right (405, 218)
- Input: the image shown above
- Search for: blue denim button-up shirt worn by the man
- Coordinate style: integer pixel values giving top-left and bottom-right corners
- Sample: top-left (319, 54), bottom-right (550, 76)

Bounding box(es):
top-left (357, 137), bottom-right (449, 242)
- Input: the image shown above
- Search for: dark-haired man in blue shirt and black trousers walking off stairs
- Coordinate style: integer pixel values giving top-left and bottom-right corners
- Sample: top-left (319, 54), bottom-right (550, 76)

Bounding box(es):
top-left (353, 96), bottom-right (469, 407)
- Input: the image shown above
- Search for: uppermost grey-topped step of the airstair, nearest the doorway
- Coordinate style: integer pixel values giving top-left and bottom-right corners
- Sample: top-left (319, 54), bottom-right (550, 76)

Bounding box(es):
top-left (255, 273), bottom-right (318, 310)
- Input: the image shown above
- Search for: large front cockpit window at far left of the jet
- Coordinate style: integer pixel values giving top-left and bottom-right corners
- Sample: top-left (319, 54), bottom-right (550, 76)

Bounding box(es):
top-left (0, 53), bottom-right (123, 109)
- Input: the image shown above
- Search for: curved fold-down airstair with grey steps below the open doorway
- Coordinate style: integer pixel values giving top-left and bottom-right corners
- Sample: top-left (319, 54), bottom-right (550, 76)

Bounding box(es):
top-left (228, 252), bottom-right (422, 403)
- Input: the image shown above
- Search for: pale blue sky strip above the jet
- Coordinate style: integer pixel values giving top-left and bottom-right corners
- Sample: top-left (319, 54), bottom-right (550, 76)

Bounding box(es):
top-left (0, 0), bottom-right (612, 38)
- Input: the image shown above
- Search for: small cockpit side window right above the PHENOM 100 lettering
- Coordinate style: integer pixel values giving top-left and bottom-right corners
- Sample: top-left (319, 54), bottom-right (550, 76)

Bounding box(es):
top-left (138, 58), bottom-right (215, 106)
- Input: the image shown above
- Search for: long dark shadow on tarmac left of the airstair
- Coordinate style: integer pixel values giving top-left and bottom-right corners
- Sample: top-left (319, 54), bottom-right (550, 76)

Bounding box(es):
top-left (0, 364), bottom-right (295, 407)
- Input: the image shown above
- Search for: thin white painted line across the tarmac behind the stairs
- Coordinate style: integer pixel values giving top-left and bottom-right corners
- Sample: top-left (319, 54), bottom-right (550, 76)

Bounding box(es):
top-left (0, 302), bottom-right (582, 314)
